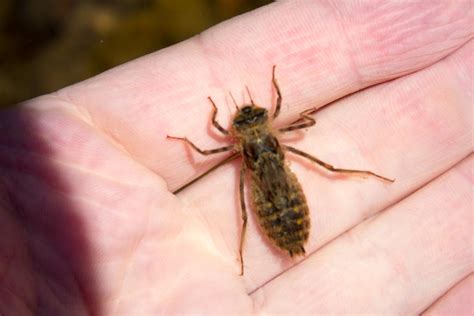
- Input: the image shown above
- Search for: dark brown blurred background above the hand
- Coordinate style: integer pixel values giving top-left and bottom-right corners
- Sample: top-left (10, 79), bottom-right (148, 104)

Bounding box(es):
top-left (0, 0), bottom-right (271, 108)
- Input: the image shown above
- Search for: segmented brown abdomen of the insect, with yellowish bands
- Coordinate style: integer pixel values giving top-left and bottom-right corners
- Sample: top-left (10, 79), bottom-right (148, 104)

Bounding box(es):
top-left (250, 153), bottom-right (310, 256)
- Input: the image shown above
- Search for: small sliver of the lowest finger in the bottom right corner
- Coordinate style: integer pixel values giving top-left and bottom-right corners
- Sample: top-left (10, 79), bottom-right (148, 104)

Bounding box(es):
top-left (423, 273), bottom-right (474, 315)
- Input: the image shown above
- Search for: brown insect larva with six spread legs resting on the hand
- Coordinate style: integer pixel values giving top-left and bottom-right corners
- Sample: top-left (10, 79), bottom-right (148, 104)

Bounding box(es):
top-left (167, 66), bottom-right (394, 275)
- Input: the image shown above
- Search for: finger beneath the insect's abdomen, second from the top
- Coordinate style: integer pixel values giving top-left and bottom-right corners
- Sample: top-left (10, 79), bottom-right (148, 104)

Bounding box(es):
top-left (181, 38), bottom-right (473, 290)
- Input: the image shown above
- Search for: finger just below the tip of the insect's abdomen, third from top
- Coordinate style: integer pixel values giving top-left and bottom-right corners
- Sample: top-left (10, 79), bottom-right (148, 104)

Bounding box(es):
top-left (253, 156), bottom-right (474, 315)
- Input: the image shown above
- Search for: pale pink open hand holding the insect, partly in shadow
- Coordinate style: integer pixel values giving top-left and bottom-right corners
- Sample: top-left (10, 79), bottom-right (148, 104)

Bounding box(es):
top-left (0, 1), bottom-right (474, 315)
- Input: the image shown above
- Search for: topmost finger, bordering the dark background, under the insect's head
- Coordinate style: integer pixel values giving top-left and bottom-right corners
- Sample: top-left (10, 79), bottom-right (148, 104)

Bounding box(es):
top-left (44, 1), bottom-right (472, 190)
